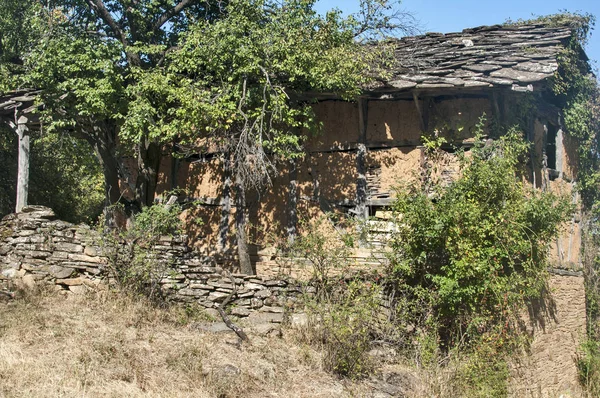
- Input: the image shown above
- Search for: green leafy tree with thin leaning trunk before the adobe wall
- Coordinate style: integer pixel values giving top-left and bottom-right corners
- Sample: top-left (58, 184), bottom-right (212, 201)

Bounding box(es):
top-left (157, 0), bottom-right (410, 273)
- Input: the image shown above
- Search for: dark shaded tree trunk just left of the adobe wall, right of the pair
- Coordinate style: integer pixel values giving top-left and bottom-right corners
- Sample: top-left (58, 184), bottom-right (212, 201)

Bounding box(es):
top-left (135, 138), bottom-right (161, 210)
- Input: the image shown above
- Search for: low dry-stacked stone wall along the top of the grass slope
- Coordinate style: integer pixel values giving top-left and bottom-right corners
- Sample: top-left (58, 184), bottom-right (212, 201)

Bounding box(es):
top-left (0, 206), bottom-right (302, 322)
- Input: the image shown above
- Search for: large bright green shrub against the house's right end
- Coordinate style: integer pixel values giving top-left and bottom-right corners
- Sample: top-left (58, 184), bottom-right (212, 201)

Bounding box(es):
top-left (389, 129), bottom-right (572, 346)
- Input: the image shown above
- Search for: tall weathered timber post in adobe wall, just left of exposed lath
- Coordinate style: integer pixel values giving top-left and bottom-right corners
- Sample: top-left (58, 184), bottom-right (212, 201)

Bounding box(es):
top-left (356, 98), bottom-right (369, 219)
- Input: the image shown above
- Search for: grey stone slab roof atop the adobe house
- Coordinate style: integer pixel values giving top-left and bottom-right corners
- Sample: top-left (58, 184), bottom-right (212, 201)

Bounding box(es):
top-left (375, 23), bottom-right (572, 91)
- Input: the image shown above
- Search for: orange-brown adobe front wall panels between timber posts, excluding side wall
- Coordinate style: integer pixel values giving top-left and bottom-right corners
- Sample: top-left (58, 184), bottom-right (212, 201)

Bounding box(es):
top-left (165, 98), bottom-right (490, 250)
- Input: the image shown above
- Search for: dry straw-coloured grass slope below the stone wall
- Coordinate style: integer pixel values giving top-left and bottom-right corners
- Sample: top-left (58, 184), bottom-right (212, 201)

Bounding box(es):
top-left (0, 292), bottom-right (371, 398)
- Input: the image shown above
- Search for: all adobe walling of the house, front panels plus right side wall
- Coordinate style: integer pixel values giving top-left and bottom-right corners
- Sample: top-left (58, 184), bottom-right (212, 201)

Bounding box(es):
top-left (152, 96), bottom-right (581, 275)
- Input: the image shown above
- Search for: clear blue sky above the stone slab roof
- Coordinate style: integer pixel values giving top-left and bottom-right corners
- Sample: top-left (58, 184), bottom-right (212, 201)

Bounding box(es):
top-left (316, 0), bottom-right (600, 68)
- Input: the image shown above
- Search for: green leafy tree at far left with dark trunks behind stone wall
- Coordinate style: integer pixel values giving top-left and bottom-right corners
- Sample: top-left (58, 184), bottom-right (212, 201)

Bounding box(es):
top-left (1, 0), bottom-right (226, 218)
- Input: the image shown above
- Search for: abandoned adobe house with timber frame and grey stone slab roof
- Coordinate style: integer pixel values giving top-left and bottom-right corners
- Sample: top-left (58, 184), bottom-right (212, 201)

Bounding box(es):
top-left (143, 23), bottom-right (587, 274)
